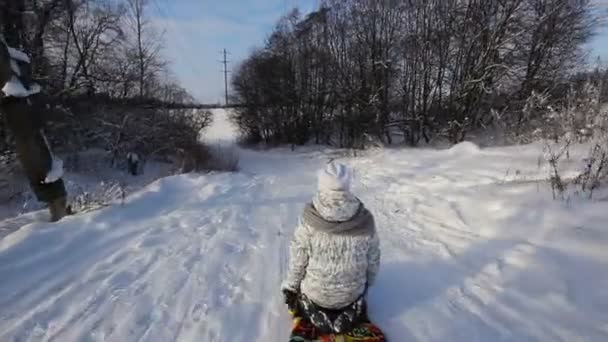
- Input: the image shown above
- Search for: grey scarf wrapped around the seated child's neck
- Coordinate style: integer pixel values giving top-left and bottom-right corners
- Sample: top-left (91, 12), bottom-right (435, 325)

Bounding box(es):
top-left (302, 203), bottom-right (375, 236)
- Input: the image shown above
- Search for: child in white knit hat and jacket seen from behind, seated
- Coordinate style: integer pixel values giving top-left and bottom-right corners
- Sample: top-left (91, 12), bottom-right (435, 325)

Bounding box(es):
top-left (281, 163), bottom-right (380, 334)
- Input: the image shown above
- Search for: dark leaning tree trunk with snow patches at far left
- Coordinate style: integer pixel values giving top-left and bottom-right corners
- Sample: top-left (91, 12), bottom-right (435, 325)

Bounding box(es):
top-left (0, 0), bottom-right (68, 221)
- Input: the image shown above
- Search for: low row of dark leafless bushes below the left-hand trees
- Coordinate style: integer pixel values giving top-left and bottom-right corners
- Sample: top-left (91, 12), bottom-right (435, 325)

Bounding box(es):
top-left (48, 101), bottom-right (212, 169)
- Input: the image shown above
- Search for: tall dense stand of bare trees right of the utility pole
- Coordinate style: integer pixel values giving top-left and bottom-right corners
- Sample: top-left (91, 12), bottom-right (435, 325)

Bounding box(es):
top-left (232, 0), bottom-right (597, 147)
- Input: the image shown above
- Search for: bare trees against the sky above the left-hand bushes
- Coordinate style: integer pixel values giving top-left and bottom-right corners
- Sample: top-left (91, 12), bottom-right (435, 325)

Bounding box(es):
top-left (0, 0), bottom-right (192, 102)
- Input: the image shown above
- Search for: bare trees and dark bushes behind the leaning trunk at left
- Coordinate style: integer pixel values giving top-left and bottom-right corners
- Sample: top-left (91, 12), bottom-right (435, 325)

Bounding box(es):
top-left (0, 0), bottom-right (211, 166)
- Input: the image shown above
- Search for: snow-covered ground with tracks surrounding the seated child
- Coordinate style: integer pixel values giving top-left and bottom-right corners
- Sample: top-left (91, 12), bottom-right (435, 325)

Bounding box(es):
top-left (0, 109), bottom-right (608, 342)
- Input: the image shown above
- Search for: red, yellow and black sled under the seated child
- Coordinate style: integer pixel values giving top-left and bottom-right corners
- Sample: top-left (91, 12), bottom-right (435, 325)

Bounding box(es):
top-left (289, 317), bottom-right (386, 342)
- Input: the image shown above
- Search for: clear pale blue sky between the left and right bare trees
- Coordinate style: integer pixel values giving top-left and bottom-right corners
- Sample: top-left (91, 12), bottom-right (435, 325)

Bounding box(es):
top-left (154, 0), bottom-right (608, 103)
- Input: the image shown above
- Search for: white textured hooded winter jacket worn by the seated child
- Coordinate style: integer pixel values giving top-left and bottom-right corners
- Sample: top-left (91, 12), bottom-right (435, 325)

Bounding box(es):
top-left (282, 191), bottom-right (380, 309)
